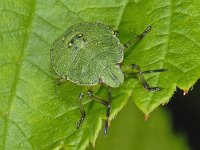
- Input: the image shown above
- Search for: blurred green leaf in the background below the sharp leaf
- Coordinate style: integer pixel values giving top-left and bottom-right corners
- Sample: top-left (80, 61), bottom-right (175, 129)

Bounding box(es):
top-left (88, 101), bottom-right (189, 150)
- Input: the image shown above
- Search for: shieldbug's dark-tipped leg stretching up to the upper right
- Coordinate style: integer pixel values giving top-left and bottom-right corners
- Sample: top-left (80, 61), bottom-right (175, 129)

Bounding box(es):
top-left (124, 26), bottom-right (151, 48)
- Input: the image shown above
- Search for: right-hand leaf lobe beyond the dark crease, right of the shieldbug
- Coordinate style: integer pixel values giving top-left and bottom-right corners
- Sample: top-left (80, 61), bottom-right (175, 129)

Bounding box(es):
top-left (119, 0), bottom-right (200, 115)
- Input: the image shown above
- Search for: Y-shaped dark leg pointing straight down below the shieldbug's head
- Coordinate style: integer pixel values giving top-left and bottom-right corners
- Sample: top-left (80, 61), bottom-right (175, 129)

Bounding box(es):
top-left (88, 88), bottom-right (111, 134)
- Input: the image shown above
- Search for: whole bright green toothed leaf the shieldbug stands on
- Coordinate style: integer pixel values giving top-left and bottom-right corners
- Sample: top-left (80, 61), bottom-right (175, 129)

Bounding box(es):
top-left (0, 0), bottom-right (200, 150)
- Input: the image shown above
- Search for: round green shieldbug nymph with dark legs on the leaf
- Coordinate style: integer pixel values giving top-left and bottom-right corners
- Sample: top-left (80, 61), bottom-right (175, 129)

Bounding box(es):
top-left (50, 22), bottom-right (166, 134)
